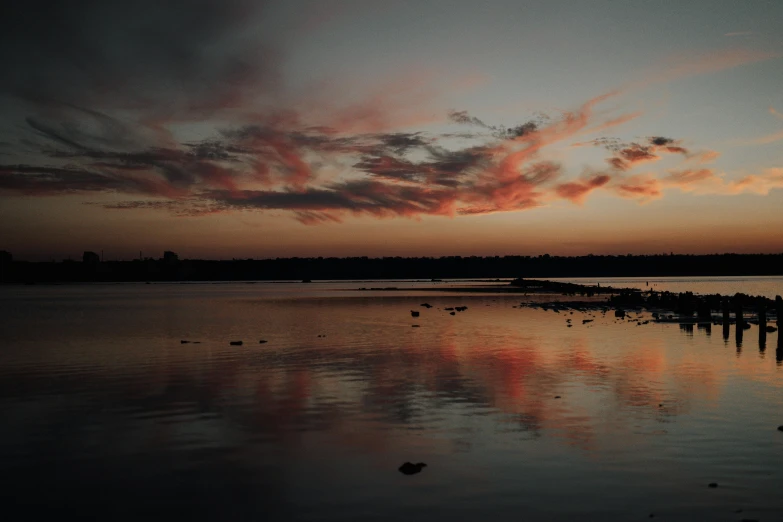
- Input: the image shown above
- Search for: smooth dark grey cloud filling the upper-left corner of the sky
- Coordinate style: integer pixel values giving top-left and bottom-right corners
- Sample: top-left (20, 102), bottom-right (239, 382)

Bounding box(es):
top-left (0, 0), bottom-right (277, 116)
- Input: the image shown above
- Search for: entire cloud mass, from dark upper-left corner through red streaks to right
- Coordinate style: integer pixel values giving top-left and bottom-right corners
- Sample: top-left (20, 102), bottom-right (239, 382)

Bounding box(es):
top-left (0, 0), bottom-right (783, 224)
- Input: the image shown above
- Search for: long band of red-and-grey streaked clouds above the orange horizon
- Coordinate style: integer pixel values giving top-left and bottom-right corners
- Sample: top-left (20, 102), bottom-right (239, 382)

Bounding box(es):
top-left (0, 83), bottom-right (783, 225)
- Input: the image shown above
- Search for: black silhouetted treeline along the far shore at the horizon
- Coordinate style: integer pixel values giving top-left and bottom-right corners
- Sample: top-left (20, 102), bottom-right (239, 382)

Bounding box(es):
top-left (0, 252), bottom-right (783, 283)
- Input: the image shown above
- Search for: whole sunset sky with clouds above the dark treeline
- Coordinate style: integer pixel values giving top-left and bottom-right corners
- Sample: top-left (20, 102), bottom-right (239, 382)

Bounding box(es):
top-left (0, 0), bottom-right (783, 260)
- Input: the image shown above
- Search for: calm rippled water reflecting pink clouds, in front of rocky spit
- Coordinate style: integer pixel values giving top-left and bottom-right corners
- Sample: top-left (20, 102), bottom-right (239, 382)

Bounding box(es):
top-left (0, 283), bottom-right (783, 521)
